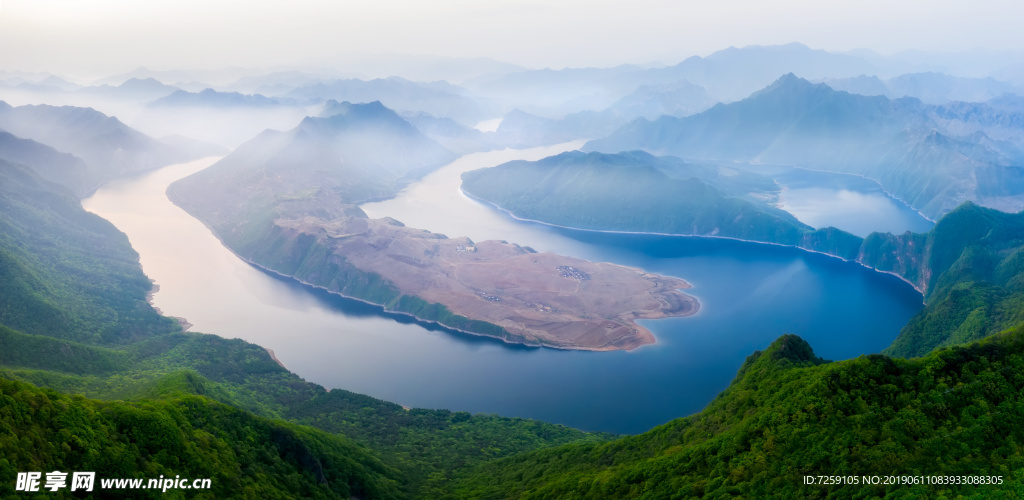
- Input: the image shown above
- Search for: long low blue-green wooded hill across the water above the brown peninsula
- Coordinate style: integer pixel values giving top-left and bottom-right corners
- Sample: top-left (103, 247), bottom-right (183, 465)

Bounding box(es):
top-left (462, 152), bottom-right (812, 245)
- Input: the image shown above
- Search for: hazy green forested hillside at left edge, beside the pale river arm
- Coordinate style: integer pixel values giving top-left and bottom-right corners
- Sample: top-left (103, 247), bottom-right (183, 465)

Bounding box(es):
top-left (0, 160), bottom-right (179, 344)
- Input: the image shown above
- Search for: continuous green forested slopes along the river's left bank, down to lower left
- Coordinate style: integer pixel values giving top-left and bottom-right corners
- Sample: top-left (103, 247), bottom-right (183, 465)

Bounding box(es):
top-left (0, 157), bottom-right (609, 499)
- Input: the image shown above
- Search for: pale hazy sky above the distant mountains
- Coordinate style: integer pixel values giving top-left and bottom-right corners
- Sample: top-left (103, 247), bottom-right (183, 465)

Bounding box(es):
top-left (0, 0), bottom-right (1024, 76)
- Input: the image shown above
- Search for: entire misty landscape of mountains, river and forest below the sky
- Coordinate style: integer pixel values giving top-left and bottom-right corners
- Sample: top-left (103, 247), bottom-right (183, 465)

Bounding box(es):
top-left (6, 44), bottom-right (1024, 498)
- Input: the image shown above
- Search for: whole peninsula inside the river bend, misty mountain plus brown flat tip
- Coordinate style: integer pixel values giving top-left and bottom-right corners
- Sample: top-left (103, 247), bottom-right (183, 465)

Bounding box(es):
top-left (168, 102), bottom-right (698, 350)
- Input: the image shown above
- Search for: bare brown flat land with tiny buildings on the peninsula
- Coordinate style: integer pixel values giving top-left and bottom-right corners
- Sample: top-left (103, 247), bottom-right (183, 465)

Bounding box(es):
top-left (274, 217), bottom-right (699, 350)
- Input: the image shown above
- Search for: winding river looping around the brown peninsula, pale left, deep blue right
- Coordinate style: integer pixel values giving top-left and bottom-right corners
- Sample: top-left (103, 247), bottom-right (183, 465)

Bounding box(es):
top-left (84, 143), bottom-right (922, 432)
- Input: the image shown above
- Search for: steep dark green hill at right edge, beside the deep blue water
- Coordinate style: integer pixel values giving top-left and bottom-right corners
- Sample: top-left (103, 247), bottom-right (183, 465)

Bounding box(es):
top-left (861, 202), bottom-right (1024, 358)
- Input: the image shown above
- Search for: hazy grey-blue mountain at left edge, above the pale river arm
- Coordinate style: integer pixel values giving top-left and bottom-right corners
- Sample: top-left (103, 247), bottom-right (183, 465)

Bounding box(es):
top-left (0, 101), bottom-right (217, 196)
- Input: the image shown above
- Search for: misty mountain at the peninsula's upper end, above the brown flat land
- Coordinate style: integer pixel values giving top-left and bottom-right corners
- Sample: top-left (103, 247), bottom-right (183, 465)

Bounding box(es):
top-left (168, 101), bottom-right (455, 241)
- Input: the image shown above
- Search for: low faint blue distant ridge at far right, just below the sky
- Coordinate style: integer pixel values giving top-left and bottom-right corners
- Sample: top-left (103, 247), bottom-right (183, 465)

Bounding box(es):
top-left (824, 72), bottom-right (1020, 105)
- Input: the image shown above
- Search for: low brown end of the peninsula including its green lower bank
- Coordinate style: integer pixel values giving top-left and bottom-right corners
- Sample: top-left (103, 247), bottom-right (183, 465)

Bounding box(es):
top-left (255, 217), bottom-right (698, 350)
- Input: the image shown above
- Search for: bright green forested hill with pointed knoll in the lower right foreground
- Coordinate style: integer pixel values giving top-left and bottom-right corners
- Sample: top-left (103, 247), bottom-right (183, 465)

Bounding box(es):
top-left (451, 329), bottom-right (1024, 499)
